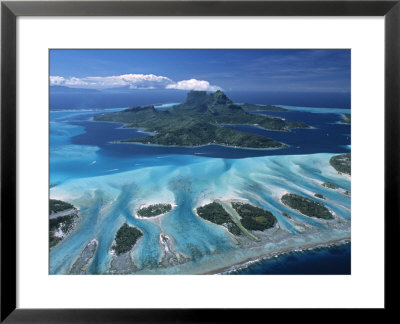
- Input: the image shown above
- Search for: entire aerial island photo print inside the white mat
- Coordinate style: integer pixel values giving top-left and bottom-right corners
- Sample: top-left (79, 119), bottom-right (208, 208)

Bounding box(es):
top-left (49, 49), bottom-right (351, 275)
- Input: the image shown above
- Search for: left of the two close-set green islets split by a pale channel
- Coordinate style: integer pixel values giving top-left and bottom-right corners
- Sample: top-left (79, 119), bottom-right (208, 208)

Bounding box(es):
top-left (196, 202), bottom-right (241, 235)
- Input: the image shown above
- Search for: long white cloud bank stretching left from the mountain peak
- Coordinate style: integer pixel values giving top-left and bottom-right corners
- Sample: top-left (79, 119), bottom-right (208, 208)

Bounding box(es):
top-left (50, 74), bottom-right (221, 91)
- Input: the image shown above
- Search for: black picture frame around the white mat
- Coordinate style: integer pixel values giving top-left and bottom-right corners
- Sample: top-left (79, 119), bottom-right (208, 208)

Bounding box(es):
top-left (0, 0), bottom-right (400, 323)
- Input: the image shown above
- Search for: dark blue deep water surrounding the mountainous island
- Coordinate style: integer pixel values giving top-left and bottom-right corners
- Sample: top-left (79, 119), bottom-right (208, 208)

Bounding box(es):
top-left (69, 111), bottom-right (351, 163)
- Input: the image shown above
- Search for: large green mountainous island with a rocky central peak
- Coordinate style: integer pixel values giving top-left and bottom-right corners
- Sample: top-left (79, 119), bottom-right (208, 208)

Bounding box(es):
top-left (94, 91), bottom-right (309, 148)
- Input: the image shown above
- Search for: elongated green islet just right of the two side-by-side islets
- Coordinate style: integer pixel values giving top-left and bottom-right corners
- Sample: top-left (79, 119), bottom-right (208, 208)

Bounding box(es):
top-left (281, 193), bottom-right (333, 219)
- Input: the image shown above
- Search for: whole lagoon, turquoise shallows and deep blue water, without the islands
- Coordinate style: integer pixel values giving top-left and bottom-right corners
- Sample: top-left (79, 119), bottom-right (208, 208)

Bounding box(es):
top-left (49, 109), bottom-right (351, 274)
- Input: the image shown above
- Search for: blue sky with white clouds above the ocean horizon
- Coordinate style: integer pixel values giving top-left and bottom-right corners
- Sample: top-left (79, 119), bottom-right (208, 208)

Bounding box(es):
top-left (50, 50), bottom-right (350, 93)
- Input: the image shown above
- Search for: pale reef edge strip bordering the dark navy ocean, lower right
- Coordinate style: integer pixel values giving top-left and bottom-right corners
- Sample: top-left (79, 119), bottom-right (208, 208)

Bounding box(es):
top-left (200, 237), bottom-right (351, 275)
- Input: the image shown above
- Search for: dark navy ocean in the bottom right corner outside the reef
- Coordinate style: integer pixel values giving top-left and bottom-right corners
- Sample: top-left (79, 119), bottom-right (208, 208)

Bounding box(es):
top-left (230, 243), bottom-right (351, 275)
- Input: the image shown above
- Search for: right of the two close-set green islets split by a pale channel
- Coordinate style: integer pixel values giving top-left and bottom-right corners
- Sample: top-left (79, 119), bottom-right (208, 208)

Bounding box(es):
top-left (232, 202), bottom-right (276, 231)
